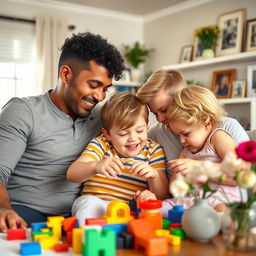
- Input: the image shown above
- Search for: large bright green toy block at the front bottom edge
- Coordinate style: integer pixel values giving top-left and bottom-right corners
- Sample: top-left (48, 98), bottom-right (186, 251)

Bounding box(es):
top-left (82, 229), bottom-right (116, 256)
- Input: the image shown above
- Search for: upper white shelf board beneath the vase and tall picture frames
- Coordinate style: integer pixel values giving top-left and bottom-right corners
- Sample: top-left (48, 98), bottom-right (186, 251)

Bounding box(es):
top-left (162, 51), bottom-right (256, 70)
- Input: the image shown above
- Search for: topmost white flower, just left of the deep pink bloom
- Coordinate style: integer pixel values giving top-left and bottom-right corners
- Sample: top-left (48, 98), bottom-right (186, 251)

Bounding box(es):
top-left (221, 152), bottom-right (242, 178)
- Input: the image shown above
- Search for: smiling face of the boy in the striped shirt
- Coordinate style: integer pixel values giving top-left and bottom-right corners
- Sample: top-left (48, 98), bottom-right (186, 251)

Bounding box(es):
top-left (103, 115), bottom-right (148, 157)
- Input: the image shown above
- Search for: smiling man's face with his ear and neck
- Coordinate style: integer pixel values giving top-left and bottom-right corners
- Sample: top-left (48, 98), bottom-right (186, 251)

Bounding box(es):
top-left (54, 60), bottom-right (112, 119)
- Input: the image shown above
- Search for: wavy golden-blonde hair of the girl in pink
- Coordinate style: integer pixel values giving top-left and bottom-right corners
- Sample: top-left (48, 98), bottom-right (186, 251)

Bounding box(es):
top-left (168, 85), bottom-right (226, 127)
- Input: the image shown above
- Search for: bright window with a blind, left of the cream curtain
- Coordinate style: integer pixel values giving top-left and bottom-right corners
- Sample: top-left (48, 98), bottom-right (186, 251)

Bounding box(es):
top-left (0, 20), bottom-right (36, 108)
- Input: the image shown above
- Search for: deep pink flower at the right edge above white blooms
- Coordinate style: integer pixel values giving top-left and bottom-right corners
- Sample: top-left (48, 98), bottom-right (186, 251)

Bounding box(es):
top-left (236, 140), bottom-right (256, 163)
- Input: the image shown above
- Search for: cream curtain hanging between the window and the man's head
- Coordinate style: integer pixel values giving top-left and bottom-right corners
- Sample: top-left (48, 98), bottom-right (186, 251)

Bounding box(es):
top-left (36, 16), bottom-right (68, 94)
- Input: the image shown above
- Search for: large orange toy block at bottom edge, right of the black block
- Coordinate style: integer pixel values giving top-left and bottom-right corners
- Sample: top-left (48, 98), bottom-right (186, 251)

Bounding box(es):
top-left (127, 219), bottom-right (168, 256)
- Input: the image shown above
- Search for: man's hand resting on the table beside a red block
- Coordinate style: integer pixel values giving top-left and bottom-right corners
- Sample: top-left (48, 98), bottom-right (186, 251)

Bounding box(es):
top-left (0, 209), bottom-right (28, 233)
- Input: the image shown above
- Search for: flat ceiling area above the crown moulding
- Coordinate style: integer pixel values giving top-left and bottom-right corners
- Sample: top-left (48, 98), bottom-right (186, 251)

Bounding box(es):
top-left (52, 0), bottom-right (188, 16)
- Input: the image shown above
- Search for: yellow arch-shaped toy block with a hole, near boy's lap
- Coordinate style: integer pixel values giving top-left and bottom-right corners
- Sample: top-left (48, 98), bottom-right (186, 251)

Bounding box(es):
top-left (103, 200), bottom-right (134, 224)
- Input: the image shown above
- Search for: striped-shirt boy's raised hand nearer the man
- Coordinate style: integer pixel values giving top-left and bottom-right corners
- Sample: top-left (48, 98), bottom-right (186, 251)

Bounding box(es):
top-left (96, 157), bottom-right (124, 178)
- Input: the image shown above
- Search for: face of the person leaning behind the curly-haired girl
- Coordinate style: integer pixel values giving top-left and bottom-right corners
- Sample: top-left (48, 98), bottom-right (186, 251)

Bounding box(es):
top-left (148, 84), bottom-right (185, 126)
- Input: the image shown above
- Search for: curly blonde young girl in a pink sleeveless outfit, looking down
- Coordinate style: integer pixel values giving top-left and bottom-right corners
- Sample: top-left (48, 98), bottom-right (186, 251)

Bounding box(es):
top-left (162, 85), bottom-right (240, 216)
